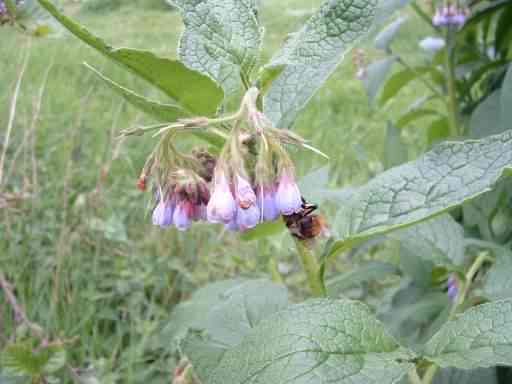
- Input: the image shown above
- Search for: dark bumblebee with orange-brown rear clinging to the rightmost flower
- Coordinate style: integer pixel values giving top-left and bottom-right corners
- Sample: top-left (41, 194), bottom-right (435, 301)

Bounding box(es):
top-left (283, 198), bottom-right (328, 240)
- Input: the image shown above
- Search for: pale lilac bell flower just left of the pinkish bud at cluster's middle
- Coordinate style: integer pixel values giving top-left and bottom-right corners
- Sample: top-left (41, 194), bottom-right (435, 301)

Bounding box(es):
top-left (206, 172), bottom-right (236, 224)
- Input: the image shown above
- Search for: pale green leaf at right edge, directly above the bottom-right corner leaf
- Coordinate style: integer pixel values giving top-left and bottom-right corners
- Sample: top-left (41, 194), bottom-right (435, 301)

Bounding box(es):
top-left (483, 246), bottom-right (512, 300)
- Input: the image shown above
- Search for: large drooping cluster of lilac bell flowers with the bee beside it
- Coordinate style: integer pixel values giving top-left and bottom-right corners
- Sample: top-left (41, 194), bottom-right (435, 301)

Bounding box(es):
top-left (138, 88), bottom-right (310, 231)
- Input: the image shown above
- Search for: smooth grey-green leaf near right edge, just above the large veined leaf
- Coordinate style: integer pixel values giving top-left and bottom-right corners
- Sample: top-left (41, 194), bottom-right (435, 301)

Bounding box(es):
top-left (469, 91), bottom-right (504, 139)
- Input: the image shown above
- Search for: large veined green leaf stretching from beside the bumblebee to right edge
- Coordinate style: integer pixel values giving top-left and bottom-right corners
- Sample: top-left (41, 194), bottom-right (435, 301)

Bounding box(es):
top-left (332, 131), bottom-right (512, 253)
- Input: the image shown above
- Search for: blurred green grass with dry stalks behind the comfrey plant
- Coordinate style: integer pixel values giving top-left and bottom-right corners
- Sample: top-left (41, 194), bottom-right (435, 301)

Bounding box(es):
top-left (0, 0), bottom-right (432, 383)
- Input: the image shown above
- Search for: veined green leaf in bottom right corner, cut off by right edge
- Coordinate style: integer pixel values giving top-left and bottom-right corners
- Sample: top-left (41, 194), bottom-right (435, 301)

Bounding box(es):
top-left (424, 299), bottom-right (512, 369)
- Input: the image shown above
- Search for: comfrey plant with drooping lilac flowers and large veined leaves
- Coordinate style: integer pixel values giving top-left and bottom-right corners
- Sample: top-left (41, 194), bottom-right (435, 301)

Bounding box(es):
top-left (27, 0), bottom-right (512, 384)
